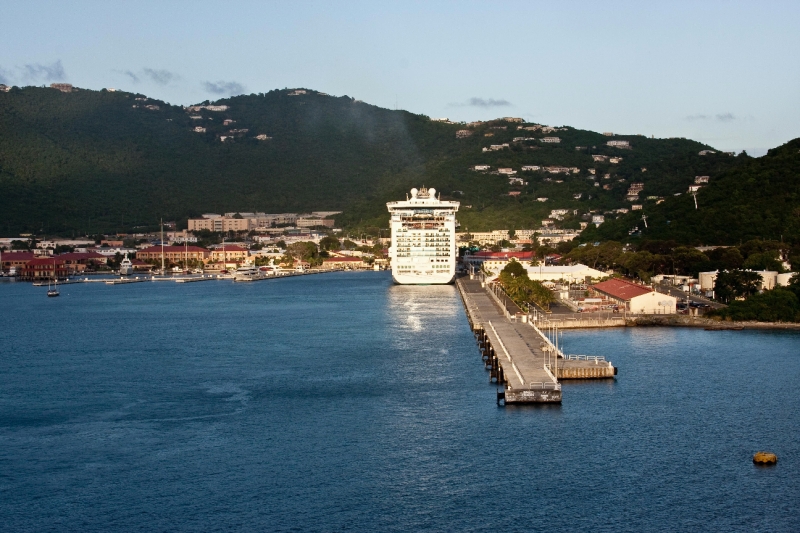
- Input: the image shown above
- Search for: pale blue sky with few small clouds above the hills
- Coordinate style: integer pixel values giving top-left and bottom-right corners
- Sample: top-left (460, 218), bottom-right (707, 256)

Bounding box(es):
top-left (0, 0), bottom-right (800, 155)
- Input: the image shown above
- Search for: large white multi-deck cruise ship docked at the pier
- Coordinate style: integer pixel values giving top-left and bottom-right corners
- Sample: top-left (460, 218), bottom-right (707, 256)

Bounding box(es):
top-left (386, 187), bottom-right (459, 285)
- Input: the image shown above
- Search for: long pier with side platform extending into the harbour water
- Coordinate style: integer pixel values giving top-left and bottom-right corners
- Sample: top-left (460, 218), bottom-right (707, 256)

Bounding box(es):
top-left (456, 278), bottom-right (617, 404)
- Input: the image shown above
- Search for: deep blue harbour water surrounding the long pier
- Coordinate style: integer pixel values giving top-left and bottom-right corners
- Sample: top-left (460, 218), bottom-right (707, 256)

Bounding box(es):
top-left (0, 272), bottom-right (800, 531)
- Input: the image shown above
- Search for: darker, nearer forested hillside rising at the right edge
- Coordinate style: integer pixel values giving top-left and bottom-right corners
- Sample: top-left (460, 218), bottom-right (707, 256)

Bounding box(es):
top-left (582, 139), bottom-right (800, 244)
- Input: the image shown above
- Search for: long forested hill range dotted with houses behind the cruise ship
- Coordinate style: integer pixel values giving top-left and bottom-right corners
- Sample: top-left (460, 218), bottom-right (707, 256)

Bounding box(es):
top-left (0, 87), bottom-right (796, 239)
